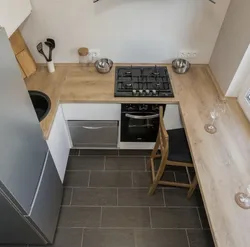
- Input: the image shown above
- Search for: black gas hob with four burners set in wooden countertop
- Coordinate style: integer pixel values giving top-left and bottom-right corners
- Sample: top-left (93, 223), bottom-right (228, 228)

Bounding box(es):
top-left (115, 66), bottom-right (174, 97)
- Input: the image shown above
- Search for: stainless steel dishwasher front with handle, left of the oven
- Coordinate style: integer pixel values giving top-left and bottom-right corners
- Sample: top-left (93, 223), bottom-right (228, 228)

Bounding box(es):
top-left (68, 120), bottom-right (118, 148)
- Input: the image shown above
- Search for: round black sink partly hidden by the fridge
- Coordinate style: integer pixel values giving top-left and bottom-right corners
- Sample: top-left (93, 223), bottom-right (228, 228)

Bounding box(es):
top-left (29, 91), bottom-right (51, 122)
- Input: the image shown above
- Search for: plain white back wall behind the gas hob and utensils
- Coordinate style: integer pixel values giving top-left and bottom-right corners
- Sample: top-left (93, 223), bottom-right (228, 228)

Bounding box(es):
top-left (22, 0), bottom-right (230, 63)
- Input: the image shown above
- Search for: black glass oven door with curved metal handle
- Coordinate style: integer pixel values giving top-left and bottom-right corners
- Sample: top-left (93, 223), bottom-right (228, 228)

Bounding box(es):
top-left (121, 112), bottom-right (159, 142)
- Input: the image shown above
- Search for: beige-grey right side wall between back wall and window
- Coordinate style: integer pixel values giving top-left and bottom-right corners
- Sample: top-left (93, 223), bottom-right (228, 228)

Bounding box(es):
top-left (209, 0), bottom-right (250, 96)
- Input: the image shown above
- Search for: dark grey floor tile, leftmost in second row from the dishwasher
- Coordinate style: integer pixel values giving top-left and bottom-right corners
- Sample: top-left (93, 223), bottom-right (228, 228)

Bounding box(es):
top-left (67, 156), bottom-right (104, 170)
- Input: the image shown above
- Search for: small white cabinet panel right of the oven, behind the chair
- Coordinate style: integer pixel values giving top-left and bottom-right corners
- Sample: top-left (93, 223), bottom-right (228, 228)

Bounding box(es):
top-left (164, 104), bottom-right (183, 130)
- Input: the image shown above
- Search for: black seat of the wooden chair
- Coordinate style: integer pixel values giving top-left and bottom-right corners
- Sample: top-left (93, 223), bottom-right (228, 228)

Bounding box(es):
top-left (167, 128), bottom-right (193, 163)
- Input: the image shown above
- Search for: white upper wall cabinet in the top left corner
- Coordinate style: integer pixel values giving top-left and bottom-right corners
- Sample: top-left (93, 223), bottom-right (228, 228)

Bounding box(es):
top-left (0, 0), bottom-right (32, 37)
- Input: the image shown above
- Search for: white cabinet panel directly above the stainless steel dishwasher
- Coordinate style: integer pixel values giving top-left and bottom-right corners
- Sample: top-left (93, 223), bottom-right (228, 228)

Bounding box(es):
top-left (62, 103), bottom-right (121, 120)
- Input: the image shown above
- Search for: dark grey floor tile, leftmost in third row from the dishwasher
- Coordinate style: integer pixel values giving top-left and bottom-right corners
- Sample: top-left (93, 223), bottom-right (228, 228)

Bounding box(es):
top-left (64, 171), bottom-right (89, 187)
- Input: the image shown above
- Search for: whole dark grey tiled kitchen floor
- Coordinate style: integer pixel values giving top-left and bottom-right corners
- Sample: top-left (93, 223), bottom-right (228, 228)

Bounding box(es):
top-left (51, 150), bottom-right (214, 247)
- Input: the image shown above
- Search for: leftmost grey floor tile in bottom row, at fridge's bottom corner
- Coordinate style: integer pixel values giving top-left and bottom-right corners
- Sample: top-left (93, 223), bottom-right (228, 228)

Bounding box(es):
top-left (51, 228), bottom-right (83, 247)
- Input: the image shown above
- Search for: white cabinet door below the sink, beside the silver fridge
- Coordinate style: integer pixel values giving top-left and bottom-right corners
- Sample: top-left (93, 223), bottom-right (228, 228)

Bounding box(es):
top-left (47, 106), bottom-right (71, 182)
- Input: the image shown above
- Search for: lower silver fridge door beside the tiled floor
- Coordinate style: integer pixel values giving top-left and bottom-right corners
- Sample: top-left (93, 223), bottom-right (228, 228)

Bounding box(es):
top-left (27, 152), bottom-right (63, 243)
